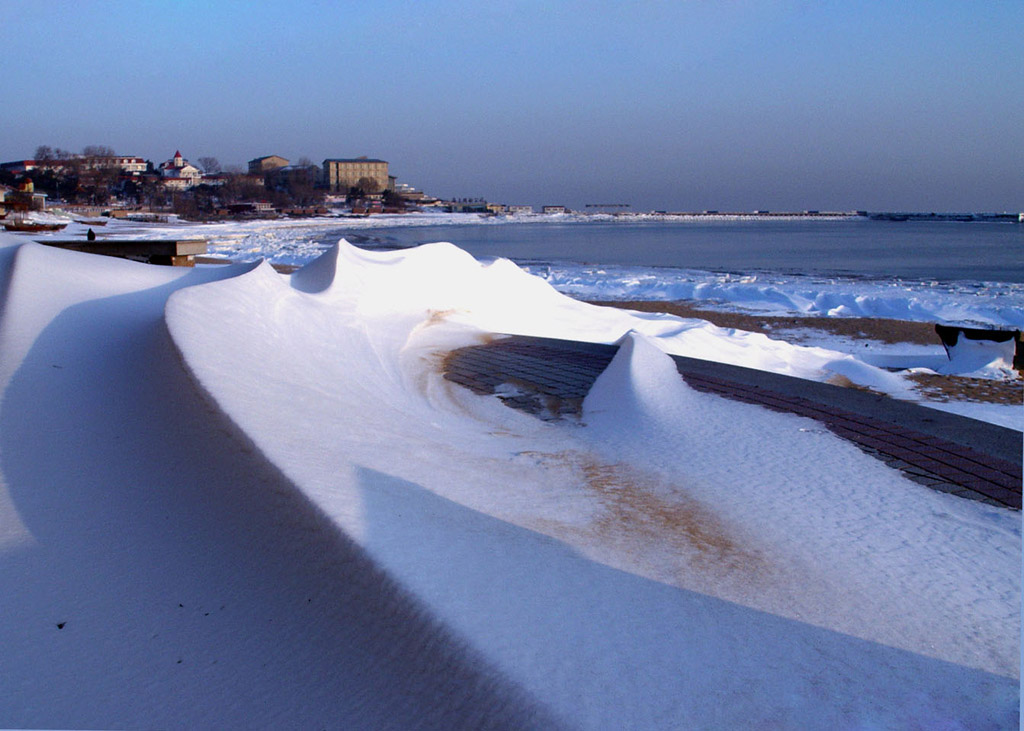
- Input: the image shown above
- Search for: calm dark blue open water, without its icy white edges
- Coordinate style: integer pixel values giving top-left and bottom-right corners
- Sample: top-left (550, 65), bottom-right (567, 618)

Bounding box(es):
top-left (324, 219), bottom-right (1024, 283)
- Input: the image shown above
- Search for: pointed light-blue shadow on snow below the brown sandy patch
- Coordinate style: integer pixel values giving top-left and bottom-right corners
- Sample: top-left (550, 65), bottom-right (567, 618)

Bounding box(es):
top-left (359, 469), bottom-right (1019, 729)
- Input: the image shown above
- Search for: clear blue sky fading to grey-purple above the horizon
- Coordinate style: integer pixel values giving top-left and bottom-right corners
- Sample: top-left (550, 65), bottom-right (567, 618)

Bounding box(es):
top-left (0, 0), bottom-right (1024, 211)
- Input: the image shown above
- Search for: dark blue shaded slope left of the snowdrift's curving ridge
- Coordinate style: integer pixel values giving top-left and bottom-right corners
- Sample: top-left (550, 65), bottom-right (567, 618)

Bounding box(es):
top-left (0, 259), bottom-right (552, 729)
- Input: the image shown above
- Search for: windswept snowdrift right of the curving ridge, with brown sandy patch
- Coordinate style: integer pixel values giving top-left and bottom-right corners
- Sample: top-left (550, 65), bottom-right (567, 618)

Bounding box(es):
top-left (167, 237), bottom-right (1020, 728)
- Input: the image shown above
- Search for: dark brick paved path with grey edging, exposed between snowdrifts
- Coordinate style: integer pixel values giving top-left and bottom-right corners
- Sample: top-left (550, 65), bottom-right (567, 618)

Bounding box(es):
top-left (444, 336), bottom-right (1024, 510)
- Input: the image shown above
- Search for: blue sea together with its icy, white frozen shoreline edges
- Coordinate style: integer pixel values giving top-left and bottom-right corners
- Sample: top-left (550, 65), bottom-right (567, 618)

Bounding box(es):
top-left (195, 214), bottom-right (1024, 328)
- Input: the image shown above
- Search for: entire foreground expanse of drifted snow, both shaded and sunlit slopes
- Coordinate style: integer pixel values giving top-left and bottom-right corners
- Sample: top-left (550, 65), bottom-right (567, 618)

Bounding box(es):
top-left (0, 235), bottom-right (1021, 729)
